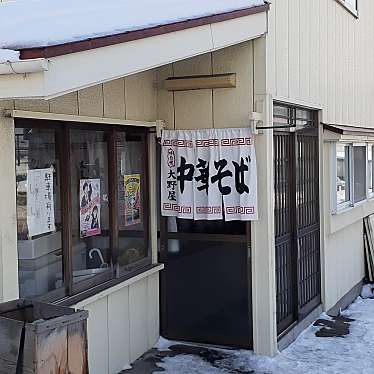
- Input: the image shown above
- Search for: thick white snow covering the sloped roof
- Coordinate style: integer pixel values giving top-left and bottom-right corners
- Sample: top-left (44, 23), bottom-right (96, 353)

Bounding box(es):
top-left (0, 0), bottom-right (264, 61)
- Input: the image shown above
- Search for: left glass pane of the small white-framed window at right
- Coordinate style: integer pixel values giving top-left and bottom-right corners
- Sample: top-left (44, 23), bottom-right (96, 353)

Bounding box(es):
top-left (336, 143), bottom-right (350, 205)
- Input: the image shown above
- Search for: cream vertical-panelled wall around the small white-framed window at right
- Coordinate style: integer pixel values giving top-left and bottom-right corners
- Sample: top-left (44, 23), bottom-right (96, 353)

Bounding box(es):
top-left (268, 0), bottom-right (374, 310)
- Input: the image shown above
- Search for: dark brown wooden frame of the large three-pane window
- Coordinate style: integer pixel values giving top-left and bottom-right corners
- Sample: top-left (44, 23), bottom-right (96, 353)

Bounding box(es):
top-left (14, 118), bottom-right (152, 302)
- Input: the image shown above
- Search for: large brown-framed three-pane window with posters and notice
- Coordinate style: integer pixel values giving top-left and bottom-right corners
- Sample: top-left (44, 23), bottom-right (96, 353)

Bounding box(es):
top-left (15, 120), bottom-right (151, 301)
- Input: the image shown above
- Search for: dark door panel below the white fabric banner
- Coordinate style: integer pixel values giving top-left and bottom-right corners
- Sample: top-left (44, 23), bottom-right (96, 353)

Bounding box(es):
top-left (160, 217), bottom-right (252, 348)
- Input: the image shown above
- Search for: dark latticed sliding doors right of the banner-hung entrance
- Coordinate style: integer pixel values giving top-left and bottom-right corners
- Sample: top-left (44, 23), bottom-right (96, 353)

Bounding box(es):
top-left (274, 104), bottom-right (321, 334)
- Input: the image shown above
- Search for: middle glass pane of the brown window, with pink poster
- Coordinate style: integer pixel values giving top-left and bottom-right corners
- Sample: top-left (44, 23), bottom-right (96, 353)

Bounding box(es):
top-left (70, 130), bottom-right (111, 283)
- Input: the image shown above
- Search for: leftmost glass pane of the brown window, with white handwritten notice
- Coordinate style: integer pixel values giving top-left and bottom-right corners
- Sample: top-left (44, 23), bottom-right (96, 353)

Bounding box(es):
top-left (15, 128), bottom-right (63, 298)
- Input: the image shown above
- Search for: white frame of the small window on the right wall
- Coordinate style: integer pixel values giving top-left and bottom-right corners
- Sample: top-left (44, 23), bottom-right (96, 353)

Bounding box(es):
top-left (330, 141), bottom-right (374, 214)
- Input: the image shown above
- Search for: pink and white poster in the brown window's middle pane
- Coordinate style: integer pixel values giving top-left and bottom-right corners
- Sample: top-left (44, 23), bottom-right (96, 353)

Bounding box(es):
top-left (79, 179), bottom-right (101, 238)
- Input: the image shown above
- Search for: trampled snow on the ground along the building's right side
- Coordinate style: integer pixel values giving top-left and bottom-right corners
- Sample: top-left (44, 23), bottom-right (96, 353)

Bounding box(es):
top-left (158, 298), bottom-right (374, 374)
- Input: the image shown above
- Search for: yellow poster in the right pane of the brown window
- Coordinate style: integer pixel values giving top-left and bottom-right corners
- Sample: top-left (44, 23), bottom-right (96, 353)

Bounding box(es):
top-left (124, 174), bottom-right (141, 226)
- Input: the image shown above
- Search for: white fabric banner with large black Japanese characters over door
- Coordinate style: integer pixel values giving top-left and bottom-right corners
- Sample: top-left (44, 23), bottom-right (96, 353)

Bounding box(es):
top-left (161, 128), bottom-right (258, 221)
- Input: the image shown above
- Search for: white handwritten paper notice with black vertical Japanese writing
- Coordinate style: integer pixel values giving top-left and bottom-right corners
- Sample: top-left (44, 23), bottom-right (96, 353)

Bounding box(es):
top-left (27, 168), bottom-right (55, 238)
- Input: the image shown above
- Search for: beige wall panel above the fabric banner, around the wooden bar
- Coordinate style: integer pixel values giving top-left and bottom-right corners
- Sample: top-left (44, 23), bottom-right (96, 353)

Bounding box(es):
top-left (157, 42), bottom-right (254, 129)
